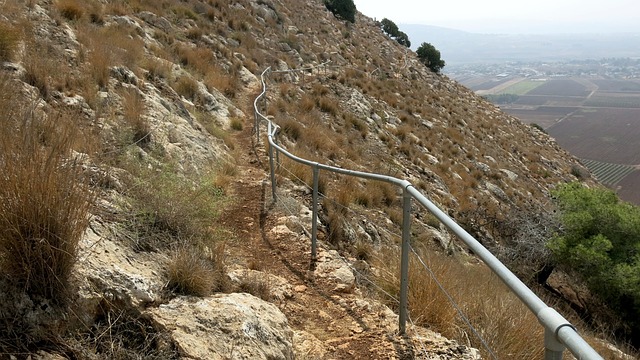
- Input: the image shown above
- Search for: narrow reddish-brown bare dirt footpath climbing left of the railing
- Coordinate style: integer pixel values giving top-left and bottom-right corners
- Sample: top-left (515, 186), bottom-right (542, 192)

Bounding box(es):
top-left (212, 83), bottom-right (415, 359)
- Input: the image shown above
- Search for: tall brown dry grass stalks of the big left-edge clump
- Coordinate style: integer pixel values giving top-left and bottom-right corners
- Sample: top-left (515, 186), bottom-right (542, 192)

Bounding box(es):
top-left (0, 108), bottom-right (95, 304)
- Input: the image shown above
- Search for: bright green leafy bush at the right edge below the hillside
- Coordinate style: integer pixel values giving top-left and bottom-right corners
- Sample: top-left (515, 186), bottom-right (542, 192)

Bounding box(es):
top-left (548, 183), bottom-right (640, 346)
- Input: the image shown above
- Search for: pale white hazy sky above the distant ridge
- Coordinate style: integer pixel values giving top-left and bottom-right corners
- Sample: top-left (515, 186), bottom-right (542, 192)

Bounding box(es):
top-left (354, 0), bottom-right (640, 34)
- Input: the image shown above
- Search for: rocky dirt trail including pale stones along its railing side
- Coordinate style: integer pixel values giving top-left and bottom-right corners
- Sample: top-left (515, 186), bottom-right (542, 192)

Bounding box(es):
top-left (202, 75), bottom-right (475, 359)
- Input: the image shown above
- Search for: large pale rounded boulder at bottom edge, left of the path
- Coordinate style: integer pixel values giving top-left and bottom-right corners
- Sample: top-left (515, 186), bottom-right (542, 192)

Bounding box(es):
top-left (149, 293), bottom-right (294, 360)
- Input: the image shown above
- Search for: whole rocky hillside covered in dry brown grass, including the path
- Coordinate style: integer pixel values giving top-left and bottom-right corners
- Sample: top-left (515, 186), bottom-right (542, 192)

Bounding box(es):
top-left (0, 0), bottom-right (636, 359)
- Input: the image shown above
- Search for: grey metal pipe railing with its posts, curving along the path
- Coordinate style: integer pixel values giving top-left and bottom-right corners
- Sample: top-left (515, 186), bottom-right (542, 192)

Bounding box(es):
top-left (253, 63), bottom-right (603, 360)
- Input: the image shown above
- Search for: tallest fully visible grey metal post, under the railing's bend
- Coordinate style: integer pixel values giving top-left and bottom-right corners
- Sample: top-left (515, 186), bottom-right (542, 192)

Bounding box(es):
top-left (399, 188), bottom-right (411, 335)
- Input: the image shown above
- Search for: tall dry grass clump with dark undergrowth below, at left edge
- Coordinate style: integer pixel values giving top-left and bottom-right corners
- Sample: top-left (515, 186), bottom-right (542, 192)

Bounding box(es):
top-left (0, 75), bottom-right (95, 350)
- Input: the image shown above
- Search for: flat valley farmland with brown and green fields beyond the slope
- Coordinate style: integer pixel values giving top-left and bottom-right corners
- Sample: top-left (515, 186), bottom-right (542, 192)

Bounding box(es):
top-left (463, 77), bottom-right (640, 204)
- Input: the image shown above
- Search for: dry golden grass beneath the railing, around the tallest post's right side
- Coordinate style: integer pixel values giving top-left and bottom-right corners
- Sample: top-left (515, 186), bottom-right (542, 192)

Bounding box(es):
top-left (376, 251), bottom-right (544, 359)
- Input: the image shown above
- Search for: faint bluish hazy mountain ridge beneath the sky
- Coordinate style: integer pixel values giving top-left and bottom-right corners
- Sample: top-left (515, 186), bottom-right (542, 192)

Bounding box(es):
top-left (399, 24), bottom-right (640, 65)
